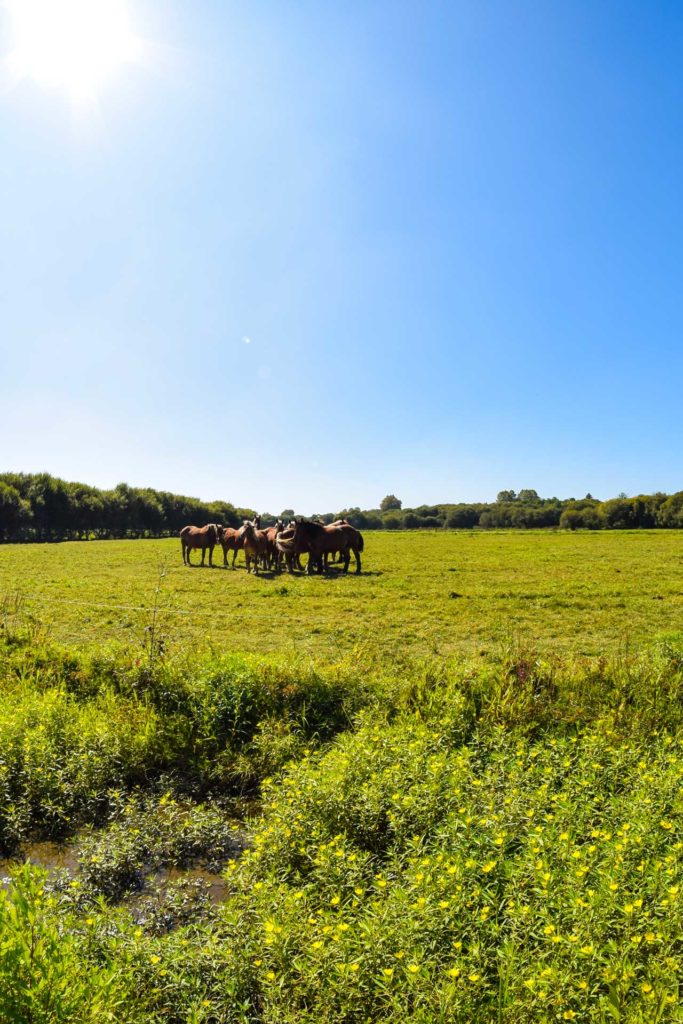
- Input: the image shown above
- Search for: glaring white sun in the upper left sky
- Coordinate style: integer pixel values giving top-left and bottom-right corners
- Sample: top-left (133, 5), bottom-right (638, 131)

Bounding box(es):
top-left (6, 0), bottom-right (141, 100)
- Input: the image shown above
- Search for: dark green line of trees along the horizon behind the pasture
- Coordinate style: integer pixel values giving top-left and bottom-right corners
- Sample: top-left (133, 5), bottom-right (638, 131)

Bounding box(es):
top-left (0, 473), bottom-right (683, 542)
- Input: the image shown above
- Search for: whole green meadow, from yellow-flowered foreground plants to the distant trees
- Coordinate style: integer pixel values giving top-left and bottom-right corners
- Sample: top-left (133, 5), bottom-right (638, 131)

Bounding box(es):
top-left (0, 531), bottom-right (683, 1024)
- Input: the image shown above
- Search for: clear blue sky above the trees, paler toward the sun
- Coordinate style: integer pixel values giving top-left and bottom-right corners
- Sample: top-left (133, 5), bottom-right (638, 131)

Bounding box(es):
top-left (0, 0), bottom-right (683, 512)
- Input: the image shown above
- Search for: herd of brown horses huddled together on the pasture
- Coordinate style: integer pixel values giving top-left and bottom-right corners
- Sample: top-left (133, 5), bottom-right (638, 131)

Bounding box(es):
top-left (180, 516), bottom-right (364, 574)
